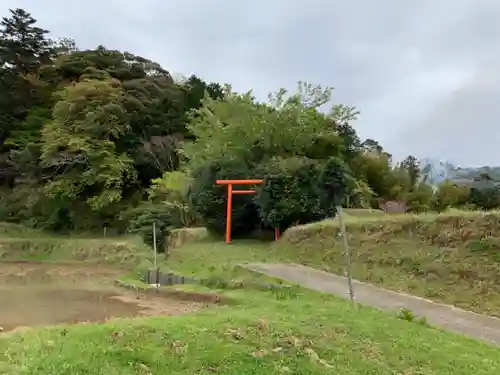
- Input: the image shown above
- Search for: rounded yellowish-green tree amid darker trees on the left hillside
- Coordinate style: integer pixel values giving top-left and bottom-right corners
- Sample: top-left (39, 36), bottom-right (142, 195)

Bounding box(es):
top-left (41, 79), bottom-right (135, 209)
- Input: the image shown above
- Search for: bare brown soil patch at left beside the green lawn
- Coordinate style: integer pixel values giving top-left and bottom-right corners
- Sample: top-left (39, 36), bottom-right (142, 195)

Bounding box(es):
top-left (0, 263), bottom-right (207, 332)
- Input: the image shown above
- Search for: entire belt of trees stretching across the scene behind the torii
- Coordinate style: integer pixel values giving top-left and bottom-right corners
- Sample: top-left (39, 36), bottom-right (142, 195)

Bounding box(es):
top-left (0, 9), bottom-right (500, 241)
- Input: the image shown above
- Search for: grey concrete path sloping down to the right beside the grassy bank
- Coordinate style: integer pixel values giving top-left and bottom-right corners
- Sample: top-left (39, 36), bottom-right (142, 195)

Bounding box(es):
top-left (241, 263), bottom-right (500, 345)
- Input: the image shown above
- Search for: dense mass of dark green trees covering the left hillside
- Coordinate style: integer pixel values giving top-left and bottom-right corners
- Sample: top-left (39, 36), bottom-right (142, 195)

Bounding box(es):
top-left (0, 9), bottom-right (226, 228)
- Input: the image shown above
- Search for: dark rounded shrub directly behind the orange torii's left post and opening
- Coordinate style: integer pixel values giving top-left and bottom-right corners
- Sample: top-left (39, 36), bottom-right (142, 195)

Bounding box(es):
top-left (188, 160), bottom-right (259, 237)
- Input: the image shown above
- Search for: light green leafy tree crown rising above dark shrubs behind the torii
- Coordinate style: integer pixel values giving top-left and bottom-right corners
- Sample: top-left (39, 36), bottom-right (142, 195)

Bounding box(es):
top-left (183, 83), bottom-right (352, 170)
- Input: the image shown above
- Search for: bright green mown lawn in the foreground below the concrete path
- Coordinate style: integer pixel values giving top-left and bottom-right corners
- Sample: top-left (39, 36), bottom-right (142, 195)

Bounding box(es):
top-left (0, 289), bottom-right (500, 375)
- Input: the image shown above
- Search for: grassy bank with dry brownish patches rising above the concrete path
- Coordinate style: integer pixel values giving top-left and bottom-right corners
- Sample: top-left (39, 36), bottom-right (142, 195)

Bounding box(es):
top-left (274, 211), bottom-right (500, 316)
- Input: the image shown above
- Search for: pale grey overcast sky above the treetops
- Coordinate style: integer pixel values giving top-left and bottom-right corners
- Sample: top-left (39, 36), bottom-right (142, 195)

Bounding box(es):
top-left (0, 0), bottom-right (500, 166)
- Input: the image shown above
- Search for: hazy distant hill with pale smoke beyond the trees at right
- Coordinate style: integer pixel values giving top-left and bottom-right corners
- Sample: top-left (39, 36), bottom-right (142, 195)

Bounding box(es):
top-left (420, 159), bottom-right (500, 185)
